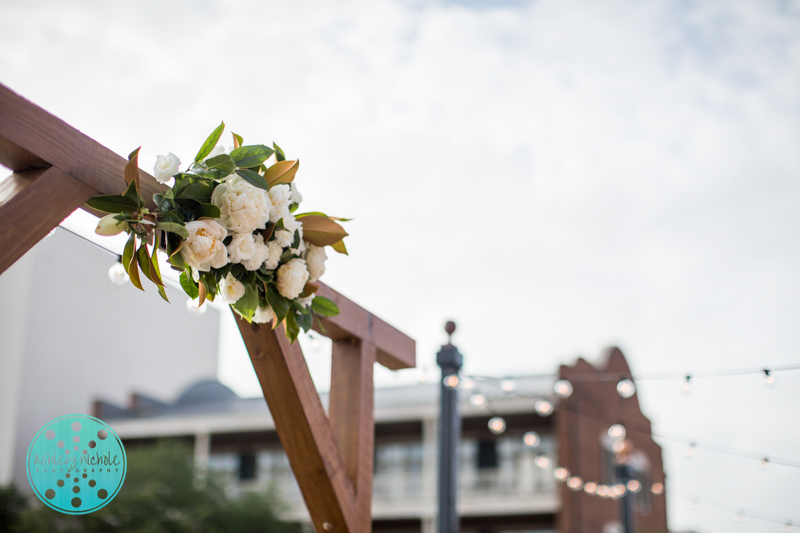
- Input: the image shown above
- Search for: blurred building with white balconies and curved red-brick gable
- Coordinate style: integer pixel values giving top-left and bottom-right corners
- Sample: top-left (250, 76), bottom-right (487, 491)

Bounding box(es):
top-left (95, 350), bottom-right (667, 533)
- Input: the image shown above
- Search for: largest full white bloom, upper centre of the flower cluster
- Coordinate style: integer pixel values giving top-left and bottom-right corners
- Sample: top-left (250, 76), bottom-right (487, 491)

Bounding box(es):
top-left (211, 175), bottom-right (272, 233)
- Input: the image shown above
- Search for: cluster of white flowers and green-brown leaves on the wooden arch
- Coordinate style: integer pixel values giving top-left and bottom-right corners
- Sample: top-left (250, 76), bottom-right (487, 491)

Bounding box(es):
top-left (87, 122), bottom-right (347, 341)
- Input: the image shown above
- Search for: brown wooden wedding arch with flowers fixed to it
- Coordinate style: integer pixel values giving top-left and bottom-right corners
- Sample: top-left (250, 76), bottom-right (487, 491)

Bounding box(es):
top-left (0, 84), bottom-right (416, 533)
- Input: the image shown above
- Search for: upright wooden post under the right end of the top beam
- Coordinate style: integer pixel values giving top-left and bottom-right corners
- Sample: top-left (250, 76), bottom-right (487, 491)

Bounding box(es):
top-left (329, 339), bottom-right (375, 533)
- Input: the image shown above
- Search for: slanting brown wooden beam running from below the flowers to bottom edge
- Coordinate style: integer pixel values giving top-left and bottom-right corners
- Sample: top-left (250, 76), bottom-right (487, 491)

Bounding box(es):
top-left (234, 313), bottom-right (361, 533)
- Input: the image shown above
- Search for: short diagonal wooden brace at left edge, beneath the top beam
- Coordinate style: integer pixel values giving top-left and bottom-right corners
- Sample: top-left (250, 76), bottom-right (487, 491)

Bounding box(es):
top-left (0, 167), bottom-right (95, 274)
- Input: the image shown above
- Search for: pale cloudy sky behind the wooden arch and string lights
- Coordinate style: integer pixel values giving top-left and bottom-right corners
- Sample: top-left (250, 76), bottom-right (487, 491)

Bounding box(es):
top-left (0, 0), bottom-right (800, 533)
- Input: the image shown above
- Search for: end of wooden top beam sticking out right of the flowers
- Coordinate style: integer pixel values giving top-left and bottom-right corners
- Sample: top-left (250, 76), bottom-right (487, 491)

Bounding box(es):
top-left (314, 283), bottom-right (417, 370)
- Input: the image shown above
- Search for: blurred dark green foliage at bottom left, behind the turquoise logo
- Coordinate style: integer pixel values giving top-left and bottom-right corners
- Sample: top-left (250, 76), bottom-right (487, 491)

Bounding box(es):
top-left (0, 442), bottom-right (300, 533)
